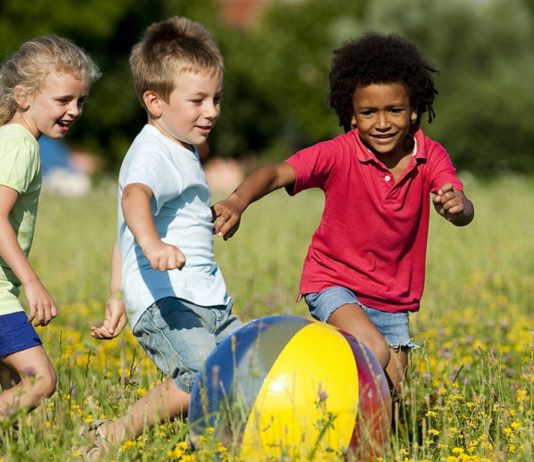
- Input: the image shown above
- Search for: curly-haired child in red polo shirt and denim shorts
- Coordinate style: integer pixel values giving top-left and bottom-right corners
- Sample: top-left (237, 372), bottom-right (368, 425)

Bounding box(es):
top-left (214, 33), bottom-right (474, 391)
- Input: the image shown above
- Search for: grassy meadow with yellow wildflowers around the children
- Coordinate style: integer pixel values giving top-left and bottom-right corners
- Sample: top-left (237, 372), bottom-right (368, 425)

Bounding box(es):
top-left (0, 174), bottom-right (534, 462)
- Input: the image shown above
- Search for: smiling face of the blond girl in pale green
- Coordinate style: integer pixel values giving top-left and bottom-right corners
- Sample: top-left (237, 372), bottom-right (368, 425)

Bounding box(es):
top-left (12, 71), bottom-right (89, 139)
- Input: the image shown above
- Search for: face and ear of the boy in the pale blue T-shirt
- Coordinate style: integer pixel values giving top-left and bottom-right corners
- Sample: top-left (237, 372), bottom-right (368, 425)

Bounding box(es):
top-left (143, 71), bottom-right (223, 147)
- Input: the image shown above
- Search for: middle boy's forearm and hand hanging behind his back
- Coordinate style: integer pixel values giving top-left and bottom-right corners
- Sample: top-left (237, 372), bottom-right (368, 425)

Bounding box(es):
top-left (91, 242), bottom-right (128, 340)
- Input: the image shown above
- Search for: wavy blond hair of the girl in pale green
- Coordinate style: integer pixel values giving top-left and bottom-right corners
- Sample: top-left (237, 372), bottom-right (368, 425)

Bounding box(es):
top-left (0, 35), bottom-right (100, 126)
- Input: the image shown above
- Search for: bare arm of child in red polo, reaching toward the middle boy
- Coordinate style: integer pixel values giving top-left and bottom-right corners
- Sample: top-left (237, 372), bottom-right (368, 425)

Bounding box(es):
top-left (213, 162), bottom-right (296, 240)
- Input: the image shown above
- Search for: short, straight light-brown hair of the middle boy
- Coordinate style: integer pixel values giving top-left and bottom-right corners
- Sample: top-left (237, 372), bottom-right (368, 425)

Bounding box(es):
top-left (130, 16), bottom-right (224, 107)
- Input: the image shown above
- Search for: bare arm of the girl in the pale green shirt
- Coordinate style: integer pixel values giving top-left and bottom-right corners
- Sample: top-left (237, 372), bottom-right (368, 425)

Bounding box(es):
top-left (0, 185), bottom-right (57, 326)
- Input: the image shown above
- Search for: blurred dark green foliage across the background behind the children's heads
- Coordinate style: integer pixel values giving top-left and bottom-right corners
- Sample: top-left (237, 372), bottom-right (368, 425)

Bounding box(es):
top-left (0, 0), bottom-right (534, 176)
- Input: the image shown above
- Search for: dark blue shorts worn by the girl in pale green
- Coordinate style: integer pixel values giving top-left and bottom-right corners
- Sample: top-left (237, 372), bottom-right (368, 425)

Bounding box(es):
top-left (0, 311), bottom-right (42, 356)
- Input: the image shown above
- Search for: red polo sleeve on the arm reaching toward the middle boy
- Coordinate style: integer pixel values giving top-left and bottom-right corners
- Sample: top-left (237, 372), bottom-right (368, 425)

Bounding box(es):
top-left (287, 141), bottom-right (337, 196)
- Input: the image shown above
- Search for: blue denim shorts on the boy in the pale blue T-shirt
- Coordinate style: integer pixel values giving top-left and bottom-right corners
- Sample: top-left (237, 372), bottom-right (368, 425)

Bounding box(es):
top-left (133, 297), bottom-right (243, 393)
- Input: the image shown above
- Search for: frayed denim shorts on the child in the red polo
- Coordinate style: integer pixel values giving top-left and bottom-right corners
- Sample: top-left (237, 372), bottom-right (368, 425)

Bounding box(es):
top-left (304, 286), bottom-right (418, 349)
